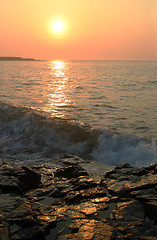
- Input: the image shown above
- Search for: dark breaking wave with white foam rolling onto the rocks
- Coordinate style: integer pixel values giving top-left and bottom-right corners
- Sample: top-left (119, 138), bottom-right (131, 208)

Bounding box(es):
top-left (0, 102), bottom-right (157, 167)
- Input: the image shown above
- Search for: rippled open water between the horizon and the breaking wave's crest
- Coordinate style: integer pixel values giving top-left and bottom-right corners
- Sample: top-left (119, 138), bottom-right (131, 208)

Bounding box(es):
top-left (0, 61), bottom-right (157, 140)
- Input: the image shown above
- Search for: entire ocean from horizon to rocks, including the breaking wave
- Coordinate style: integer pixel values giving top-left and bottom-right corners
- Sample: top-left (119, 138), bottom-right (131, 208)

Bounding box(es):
top-left (0, 60), bottom-right (157, 167)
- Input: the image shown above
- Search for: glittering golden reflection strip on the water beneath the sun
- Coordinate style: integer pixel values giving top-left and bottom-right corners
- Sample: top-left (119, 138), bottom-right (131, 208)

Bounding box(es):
top-left (43, 60), bottom-right (71, 117)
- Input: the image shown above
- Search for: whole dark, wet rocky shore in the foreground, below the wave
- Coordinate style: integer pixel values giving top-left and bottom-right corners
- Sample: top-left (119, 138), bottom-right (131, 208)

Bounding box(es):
top-left (0, 155), bottom-right (157, 240)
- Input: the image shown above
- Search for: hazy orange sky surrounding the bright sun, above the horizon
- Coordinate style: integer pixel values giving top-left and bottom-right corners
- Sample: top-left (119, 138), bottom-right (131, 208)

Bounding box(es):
top-left (0, 0), bottom-right (157, 60)
